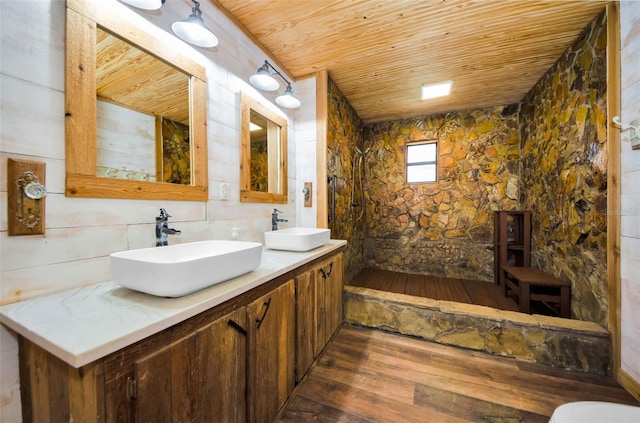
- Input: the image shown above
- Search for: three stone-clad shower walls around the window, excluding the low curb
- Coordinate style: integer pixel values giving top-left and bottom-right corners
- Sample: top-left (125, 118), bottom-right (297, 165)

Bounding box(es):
top-left (327, 4), bottom-right (608, 327)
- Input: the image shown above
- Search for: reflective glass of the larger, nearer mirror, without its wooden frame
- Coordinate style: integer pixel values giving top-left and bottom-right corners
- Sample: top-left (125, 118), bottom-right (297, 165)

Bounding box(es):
top-left (95, 27), bottom-right (191, 185)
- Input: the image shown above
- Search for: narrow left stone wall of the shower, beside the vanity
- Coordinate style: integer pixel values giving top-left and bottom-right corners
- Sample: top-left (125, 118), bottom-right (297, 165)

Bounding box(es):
top-left (327, 79), bottom-right (365, 281)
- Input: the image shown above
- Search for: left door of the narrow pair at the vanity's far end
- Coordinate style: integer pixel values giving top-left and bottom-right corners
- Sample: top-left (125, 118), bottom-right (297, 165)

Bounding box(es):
top-left (296, 269), bottom-right (317, 382)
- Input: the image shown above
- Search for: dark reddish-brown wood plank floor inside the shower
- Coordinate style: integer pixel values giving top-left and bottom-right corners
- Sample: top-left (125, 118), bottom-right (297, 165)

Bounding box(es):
top-left (350, 269), bottom-right (518, 311)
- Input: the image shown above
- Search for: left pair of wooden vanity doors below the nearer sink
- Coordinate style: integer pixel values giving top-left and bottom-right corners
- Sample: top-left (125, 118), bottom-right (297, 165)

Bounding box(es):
top-left (134, 308), bottom-right (246, 423)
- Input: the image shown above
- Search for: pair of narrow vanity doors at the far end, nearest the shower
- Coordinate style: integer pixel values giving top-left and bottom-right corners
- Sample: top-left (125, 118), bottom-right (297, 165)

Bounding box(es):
top-left (296, 253), bottom-right (344, 382)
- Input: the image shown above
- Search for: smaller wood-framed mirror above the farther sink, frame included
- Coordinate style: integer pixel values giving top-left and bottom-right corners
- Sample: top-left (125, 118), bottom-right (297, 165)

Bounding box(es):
top-left (240, 92), bottom-right (288, 203)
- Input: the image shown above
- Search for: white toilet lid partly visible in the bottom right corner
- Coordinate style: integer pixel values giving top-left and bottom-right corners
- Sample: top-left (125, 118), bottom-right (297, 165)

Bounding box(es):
top-left (549, 401), bottom-right (640, 423)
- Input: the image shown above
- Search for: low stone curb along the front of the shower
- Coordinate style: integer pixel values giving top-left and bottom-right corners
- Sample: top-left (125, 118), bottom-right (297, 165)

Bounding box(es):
top-left (344, 286), bottom-right (611, 375)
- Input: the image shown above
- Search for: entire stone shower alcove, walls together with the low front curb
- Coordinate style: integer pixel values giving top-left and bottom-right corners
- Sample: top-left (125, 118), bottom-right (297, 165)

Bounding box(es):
top-left (327, 9), bottom-right (610, 372)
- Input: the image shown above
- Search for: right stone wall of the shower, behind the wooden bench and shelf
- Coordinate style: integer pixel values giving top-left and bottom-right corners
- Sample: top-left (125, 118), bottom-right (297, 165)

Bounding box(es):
top-left (520, 14), bottom-right (607, 327)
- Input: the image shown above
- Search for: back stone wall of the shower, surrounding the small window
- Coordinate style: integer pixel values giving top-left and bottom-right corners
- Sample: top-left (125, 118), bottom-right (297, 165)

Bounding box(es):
top-left (364, 105), bottom-right (520, 281)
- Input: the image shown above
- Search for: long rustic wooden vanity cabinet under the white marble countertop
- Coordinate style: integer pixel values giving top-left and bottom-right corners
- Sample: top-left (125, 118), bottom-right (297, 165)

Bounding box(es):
top-left (18, 251), bottom-right (343, 423)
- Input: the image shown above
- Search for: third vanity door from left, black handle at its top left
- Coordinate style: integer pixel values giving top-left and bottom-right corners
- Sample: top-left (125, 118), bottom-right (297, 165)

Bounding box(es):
top-left (247, 279), bottom-right (295, 423)
